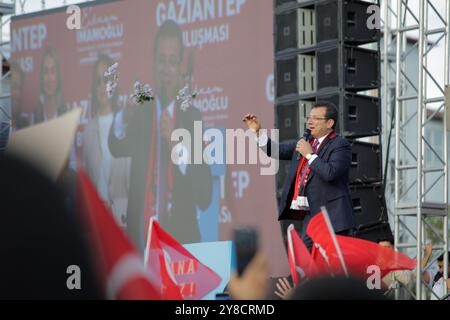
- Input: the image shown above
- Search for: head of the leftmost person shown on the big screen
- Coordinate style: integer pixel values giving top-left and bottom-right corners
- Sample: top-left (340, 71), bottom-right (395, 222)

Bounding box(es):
top-left (10, 60), bottom-right (29, 129)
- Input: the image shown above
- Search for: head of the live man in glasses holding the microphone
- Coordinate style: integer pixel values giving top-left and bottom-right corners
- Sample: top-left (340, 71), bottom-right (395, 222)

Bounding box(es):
top-left (307, 101), bottom-right (338, 139)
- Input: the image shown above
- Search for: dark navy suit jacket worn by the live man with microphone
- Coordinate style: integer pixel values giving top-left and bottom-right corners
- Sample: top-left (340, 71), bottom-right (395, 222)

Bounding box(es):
top-left (265, 131), bottom-right (354, 232)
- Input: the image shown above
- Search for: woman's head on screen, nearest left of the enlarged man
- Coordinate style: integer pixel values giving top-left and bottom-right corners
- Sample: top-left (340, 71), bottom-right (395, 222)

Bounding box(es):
top-left (91, 53), bottom-right (118, 117)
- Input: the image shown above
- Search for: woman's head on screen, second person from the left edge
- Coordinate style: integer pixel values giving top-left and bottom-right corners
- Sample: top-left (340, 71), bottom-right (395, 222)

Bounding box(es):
top-left (39, 47), bottom-right (63, 101)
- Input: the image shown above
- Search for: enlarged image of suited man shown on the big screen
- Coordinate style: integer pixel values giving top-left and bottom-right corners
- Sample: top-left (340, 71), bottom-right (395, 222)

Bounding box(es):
top-left (109, 20), bottom-right (212, 250)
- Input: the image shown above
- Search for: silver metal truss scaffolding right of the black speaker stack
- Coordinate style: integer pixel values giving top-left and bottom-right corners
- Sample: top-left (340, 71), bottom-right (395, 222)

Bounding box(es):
top-left (382, 0), bottom-right (450, 299)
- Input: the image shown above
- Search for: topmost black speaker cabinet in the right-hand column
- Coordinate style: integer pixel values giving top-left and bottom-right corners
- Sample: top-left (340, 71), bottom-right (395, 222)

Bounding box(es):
top-left (316, 0), bottom-right (380, 45)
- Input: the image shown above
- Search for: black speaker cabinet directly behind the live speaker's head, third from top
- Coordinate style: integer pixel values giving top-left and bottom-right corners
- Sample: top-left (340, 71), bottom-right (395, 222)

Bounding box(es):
top-left (317, 92), bottom-right (381, 138)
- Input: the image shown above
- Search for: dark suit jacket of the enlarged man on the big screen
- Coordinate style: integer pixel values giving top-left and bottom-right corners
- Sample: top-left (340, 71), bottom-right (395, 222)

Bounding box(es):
top-left (109, 99), bottom-right (212, 249)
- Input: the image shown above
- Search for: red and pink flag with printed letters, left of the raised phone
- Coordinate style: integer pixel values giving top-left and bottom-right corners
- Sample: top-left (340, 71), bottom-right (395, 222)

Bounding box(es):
top-left (145, 218), bottom-right (222, 300)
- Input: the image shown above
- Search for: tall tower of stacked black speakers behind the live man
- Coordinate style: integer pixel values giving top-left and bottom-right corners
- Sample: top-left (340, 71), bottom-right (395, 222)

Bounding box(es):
top-left (274, 0), bottom-right (392, 241)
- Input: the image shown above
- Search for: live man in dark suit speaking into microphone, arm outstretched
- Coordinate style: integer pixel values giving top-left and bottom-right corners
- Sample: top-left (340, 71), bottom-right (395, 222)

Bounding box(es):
top-left (243, 102), bottom-right (354, 249)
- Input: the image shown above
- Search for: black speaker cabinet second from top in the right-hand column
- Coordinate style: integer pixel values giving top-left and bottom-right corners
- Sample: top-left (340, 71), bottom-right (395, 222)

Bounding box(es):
top-left (316, 46), bottom-right (380, 93)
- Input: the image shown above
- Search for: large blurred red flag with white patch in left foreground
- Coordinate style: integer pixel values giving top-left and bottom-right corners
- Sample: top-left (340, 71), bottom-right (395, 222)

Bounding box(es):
top-left (77, 168), bottom-right (161, 300)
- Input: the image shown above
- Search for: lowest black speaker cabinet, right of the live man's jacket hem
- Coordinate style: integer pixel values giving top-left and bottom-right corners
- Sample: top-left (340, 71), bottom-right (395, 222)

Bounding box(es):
top-left (350, 184), bottom-right (388, 230)
